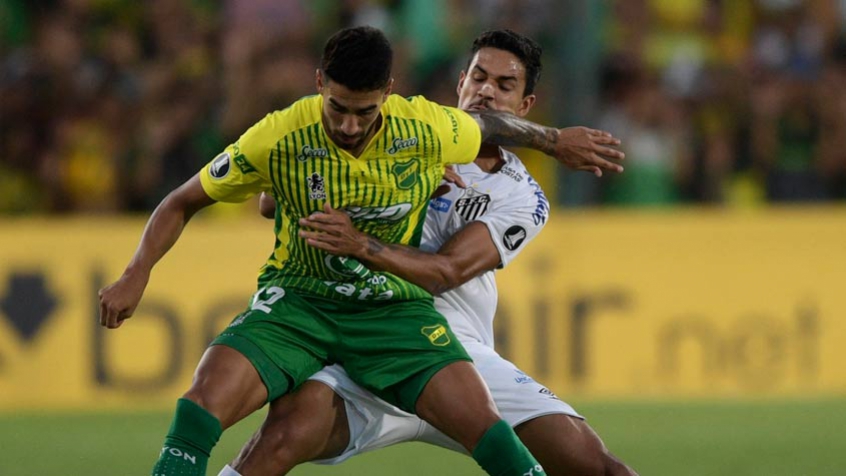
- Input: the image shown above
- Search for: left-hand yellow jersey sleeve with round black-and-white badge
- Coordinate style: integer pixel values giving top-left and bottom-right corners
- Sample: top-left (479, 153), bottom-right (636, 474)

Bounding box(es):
top-left (200, 113), bottom-right (275, 202)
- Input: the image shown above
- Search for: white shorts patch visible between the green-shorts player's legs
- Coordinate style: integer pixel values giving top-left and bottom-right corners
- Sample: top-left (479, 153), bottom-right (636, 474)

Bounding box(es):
top-left (310, 365), bottom-right (424, 464)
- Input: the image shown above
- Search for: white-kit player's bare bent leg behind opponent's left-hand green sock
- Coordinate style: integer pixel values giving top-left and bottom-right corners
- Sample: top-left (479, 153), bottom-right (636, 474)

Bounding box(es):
top-left (220, 380), bottom-right (350, 476)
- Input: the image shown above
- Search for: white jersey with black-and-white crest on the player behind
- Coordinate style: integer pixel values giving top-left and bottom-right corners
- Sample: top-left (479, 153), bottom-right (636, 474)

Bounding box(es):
top-left (420, 149), bottom-right (549, 347)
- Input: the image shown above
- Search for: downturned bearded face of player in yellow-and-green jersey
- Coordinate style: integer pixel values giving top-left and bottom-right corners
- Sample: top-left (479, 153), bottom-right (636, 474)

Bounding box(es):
top-left (317, 71), bottom-right (393, 154)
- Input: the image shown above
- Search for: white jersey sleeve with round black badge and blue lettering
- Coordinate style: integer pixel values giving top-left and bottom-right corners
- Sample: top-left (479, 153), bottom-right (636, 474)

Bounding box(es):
top-left (477, 176), bottom-right (549, 268)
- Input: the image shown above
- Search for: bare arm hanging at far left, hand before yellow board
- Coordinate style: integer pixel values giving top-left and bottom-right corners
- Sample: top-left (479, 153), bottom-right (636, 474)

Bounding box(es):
top-left (99, 175), bottom-right (215, 329)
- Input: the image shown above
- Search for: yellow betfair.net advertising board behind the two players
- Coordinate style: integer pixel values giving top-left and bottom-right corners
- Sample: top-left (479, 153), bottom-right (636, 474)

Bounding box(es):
top-left (0, 208), bottom-right (846, 410)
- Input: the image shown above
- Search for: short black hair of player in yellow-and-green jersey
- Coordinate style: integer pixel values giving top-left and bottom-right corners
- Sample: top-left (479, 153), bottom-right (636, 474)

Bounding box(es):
top-left (320, 26), bottom-right (394, 91)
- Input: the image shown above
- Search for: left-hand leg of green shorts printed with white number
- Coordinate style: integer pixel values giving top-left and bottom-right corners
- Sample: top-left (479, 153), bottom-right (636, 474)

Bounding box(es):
top-left (211, 286), bottom-right (337, 401)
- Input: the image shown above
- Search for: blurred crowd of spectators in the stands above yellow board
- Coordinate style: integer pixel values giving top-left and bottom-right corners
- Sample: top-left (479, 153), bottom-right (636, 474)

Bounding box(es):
top-left (0, 0), bottom-right (846, 215)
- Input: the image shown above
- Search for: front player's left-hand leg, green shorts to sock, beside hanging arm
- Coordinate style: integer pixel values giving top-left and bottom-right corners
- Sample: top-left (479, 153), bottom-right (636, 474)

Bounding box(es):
top-left (153, 288), bottom-right (331, 476)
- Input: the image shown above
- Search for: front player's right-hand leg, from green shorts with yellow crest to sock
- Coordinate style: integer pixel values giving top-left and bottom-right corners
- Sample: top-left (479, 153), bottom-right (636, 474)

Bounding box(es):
top-left (339, 300), bottom-right (544, 476)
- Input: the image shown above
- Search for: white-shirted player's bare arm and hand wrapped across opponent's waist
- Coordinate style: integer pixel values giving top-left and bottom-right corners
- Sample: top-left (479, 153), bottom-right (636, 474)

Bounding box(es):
top-left (300, 205), bottom-right (500, 294)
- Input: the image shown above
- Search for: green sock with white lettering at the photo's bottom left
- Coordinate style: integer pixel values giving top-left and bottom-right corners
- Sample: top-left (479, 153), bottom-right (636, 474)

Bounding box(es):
top-left (153, 398), bottom-right (223, 476)
